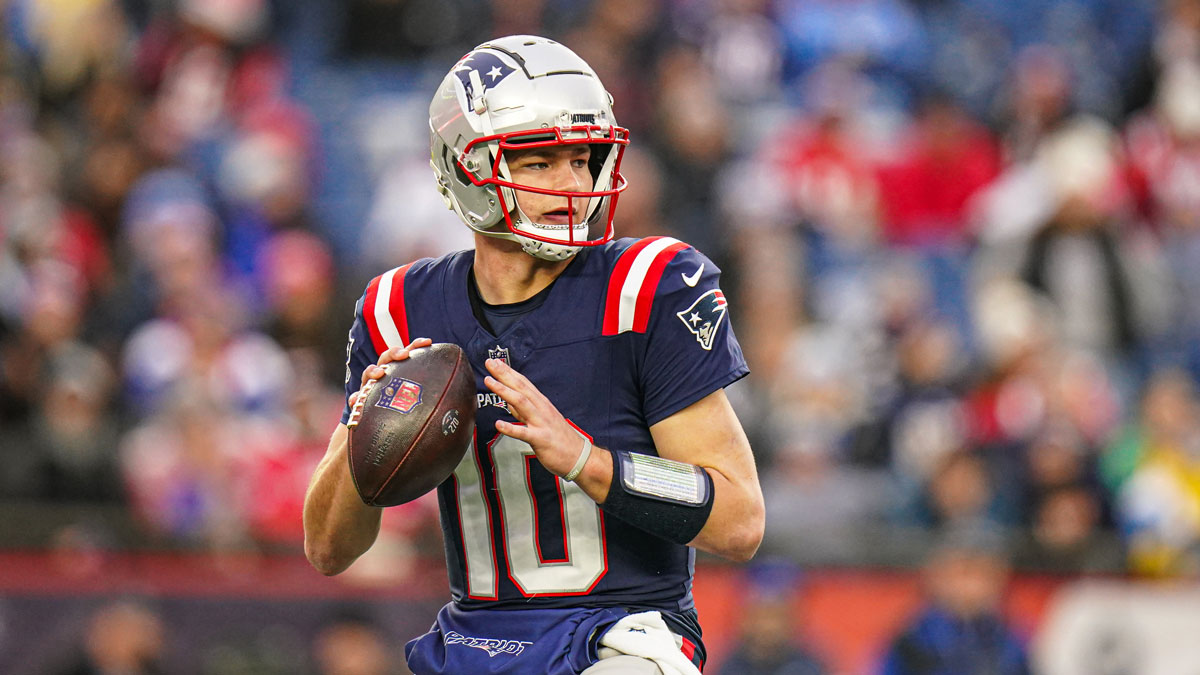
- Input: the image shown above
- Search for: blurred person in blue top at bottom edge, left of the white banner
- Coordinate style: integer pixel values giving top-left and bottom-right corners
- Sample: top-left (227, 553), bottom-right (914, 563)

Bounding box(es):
top-left (881, 524), bottom-right (1030, 675)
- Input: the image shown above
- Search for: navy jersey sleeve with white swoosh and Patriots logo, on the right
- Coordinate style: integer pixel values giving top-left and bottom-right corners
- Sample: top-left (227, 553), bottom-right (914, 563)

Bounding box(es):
top-left (642, 246), bottom-right (750, 425)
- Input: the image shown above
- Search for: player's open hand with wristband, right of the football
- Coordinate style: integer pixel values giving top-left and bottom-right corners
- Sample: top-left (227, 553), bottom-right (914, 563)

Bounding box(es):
top-left (484, 359), bottom-right (583, 476)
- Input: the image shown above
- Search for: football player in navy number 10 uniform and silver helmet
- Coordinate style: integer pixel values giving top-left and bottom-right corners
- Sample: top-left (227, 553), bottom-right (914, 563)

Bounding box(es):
top-left (304, 36), bottom-right (763, 675)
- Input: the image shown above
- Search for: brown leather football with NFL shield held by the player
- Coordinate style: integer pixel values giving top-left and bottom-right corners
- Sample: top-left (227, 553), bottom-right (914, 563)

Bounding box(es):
top-left (346, 342), bottom-right (475, 507)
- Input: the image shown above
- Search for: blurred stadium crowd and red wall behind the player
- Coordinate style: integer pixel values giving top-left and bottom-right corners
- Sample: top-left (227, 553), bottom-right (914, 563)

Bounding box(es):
top-left (0, 0), bottom-right (1200, 675)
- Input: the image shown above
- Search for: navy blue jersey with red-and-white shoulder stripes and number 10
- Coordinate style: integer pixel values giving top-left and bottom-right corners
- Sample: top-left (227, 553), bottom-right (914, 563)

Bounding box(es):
top-left (342, 237), bottom-right (748, 614)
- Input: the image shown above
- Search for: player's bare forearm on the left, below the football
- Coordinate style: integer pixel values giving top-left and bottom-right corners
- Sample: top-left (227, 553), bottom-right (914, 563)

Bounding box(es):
top-left (304, 425), bottom-right (383, 574)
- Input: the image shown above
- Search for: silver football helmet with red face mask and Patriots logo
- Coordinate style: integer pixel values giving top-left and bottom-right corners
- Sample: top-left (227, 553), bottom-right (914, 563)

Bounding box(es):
top-left (430, 35), bottom-right (629, 261)
